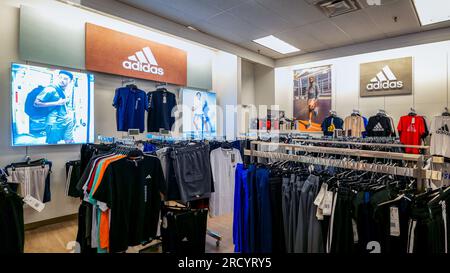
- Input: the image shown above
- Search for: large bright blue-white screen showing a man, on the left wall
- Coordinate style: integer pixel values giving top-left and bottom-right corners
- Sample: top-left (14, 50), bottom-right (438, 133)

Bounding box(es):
top-left (11, 63), bottom-right (94, 146)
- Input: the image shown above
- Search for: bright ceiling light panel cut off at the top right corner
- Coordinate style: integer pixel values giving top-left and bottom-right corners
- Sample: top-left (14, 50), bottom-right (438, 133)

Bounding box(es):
top-left (413, 0), bottom-right (450, 26)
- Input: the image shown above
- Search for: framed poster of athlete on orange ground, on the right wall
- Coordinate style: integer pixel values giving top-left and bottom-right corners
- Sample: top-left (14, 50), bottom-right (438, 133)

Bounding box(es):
top-left (293, 65), bottom-right (332, 132)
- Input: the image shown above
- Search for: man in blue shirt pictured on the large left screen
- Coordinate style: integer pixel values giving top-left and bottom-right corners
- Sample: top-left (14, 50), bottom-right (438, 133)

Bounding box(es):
top-left (34, 70), bottom-right (74, 144)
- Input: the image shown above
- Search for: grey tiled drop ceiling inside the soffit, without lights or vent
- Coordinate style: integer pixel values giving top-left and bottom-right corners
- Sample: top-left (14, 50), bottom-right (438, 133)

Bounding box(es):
top-left (119, 0), bottom-right (450, 59)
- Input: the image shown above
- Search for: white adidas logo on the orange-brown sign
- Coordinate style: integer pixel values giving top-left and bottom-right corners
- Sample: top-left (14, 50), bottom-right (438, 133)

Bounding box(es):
top-left (122, 47), bottom-right (164, 76)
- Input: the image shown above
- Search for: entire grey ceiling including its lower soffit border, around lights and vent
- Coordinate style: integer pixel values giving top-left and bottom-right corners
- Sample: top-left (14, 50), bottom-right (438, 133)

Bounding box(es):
top-left (74, 0), bottom-right (450, 67)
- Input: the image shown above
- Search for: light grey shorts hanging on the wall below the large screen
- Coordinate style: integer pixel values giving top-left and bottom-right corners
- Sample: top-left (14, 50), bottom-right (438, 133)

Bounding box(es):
top-left (5, 159), bottom-right (52, 203)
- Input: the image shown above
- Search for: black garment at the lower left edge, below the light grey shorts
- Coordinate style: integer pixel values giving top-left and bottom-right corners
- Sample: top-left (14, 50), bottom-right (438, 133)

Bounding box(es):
top-left (0, 170), bottom-right (25, 254)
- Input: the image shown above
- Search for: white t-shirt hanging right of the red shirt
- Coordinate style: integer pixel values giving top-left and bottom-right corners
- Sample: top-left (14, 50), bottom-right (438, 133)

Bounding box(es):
top-left (430, 116), bottom-right (450, 158)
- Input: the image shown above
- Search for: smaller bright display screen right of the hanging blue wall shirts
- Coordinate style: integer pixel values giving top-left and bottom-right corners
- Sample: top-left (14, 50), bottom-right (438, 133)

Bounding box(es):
top-left (181, 88), bottom-right (216, 138)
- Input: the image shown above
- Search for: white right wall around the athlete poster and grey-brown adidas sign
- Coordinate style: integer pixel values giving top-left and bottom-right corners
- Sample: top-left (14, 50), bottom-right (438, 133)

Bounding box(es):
top-left (275, 41), bottom-right (450, 127)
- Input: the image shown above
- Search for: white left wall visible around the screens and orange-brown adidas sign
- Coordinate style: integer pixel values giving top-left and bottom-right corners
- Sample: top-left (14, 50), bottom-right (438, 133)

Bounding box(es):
top-left (0, 0), bottom-right (240, 223)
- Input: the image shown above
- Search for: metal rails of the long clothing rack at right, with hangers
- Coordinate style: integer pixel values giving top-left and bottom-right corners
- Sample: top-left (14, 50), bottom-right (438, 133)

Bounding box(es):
top-left (245, 141), bottom-right (442, 190)
